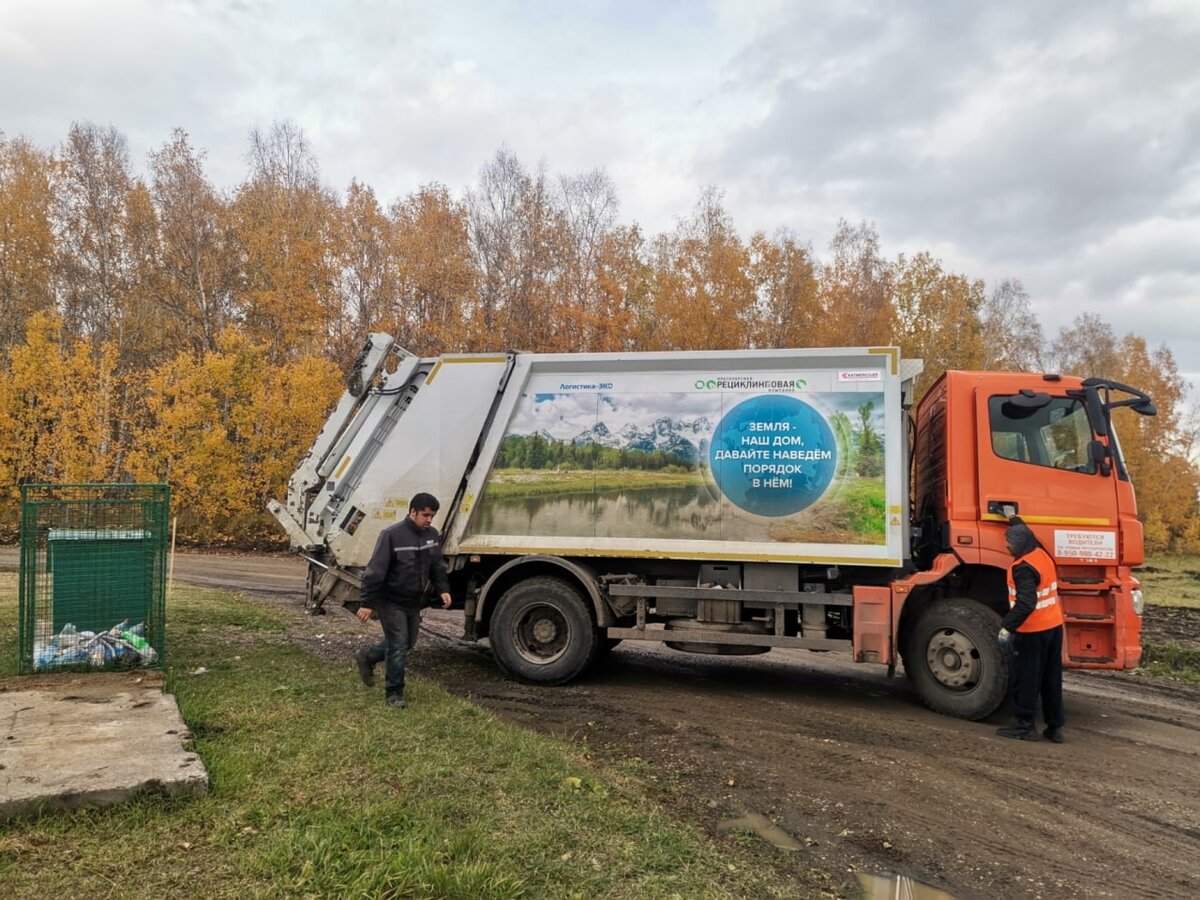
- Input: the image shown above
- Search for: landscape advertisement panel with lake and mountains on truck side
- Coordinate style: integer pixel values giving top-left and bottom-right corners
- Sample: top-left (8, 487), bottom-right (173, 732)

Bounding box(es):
top-left (470, 368), bottom-right (888, 550)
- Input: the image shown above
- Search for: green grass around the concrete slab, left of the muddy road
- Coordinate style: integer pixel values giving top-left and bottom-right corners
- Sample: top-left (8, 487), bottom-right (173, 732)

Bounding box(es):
top-left (0, 572), bottom-right (818, 898)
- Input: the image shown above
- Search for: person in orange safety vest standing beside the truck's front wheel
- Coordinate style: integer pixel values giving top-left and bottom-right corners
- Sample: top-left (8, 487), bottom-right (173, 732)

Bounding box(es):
top-left (997, 516), bottom-right (1066, 744)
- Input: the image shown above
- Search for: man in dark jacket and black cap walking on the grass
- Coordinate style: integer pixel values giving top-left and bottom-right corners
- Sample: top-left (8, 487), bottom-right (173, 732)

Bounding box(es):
top-left (354, 493), bottom-right (450, 707)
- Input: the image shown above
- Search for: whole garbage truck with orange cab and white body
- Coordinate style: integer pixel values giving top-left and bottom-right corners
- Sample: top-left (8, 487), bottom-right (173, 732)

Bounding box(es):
top-left (269, 334), bottom-right (1154, 719)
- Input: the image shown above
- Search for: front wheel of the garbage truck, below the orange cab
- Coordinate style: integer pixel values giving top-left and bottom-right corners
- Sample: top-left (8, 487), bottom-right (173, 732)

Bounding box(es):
top-left (904, 598), bottom-right (1012, 721)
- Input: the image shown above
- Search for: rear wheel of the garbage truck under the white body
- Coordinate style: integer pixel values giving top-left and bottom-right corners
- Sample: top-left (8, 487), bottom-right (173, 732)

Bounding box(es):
top-left (491, 577), bottom-right (600, 684)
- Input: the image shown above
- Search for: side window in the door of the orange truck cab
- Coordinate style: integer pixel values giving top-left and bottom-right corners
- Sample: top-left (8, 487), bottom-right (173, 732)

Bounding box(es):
top-left (988, 395), bottom-right (1096, 474)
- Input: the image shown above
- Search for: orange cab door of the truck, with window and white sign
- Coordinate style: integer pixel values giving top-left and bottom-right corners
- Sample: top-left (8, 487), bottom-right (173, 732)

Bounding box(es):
top-left (976, 386), bottom-right (1117, 563)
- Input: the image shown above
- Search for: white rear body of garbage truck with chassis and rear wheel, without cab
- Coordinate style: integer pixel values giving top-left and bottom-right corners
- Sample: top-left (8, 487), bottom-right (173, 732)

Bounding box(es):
top-left (269, 335), bottom-right (936, 712)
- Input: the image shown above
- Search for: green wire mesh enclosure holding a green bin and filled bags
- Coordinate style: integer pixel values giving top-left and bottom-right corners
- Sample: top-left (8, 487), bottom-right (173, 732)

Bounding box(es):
top-left (18, 485), bottom-right (170, 673)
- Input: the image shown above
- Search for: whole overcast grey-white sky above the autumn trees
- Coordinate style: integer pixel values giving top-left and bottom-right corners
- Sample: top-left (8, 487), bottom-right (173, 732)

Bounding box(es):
top-left (0, 0), bottom-right (1200, 397)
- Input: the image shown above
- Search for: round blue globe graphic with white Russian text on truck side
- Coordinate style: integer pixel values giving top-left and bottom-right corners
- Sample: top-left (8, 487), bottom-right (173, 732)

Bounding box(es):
top-left (708, 394), bottom-right (838, 517)
